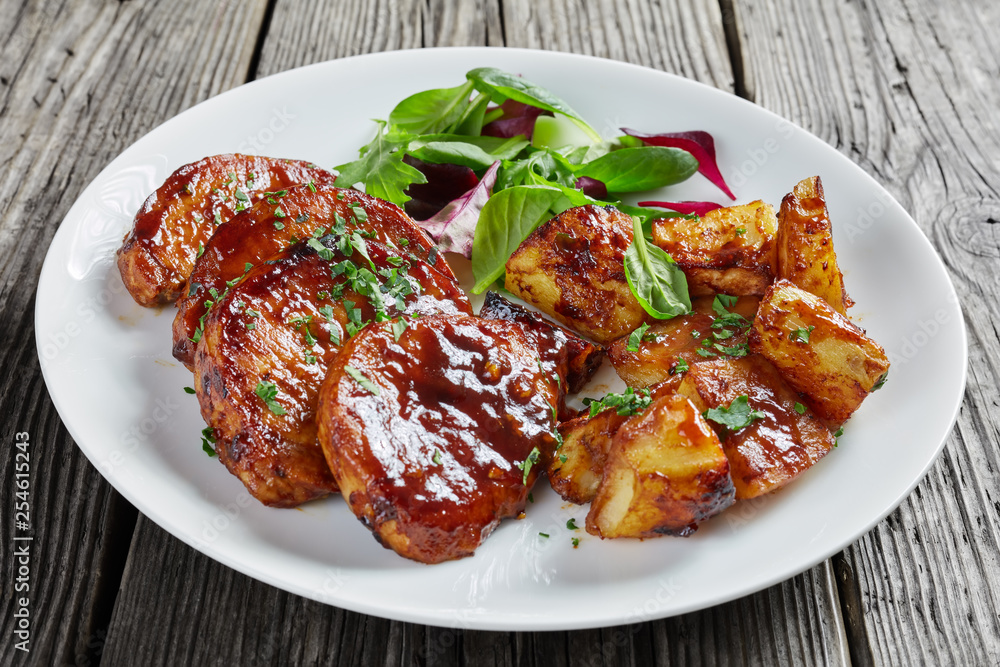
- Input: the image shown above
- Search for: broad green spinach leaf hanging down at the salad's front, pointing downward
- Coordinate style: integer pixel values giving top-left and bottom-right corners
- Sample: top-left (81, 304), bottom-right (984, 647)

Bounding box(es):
top-left (472, 185), bottom-right (562, 294)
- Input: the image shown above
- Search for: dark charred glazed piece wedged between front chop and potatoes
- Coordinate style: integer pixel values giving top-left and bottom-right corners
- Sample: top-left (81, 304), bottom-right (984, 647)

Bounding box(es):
top-left (479, 292), bottom-right (605, 394)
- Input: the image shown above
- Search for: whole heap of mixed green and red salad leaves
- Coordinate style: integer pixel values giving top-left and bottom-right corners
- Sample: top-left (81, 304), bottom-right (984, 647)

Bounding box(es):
top-left (337, 67), bottom-right (735, 319)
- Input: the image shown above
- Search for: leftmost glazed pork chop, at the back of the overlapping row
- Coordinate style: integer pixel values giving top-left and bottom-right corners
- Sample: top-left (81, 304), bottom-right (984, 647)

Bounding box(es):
top-left (118, 154), bottom-right (336, 306)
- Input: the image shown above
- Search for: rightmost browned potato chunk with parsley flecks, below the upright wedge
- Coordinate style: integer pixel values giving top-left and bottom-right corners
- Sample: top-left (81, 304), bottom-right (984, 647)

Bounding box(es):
top-left (750, 280), bottom-right (889, 425)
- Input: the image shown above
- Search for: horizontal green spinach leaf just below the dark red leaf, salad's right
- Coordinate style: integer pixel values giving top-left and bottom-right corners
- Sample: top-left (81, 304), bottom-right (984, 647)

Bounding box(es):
top-left (576, 146), bottom-right (698, 192)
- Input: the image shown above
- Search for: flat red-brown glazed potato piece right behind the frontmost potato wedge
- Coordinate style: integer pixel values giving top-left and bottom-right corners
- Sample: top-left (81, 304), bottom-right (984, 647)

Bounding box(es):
top-left (677, 354), bottom-right (835, 500)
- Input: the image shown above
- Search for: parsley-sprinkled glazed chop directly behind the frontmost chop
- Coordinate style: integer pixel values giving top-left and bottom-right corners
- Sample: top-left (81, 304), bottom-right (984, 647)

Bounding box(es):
top-left (195, 237), bottom-right (471, 507)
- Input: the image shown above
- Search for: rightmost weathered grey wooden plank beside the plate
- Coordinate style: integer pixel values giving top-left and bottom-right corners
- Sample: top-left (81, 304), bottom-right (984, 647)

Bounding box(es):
top-left (737, 0), bottom-right (1000, 665)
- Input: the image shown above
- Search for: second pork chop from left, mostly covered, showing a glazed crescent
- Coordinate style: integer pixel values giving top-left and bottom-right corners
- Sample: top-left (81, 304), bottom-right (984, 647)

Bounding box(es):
top-left (173, 185), bottom-right (454, 368)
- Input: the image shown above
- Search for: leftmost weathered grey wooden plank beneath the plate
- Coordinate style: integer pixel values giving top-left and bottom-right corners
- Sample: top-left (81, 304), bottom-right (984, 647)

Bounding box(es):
top-left (0, 0), bottom-right (264, 664)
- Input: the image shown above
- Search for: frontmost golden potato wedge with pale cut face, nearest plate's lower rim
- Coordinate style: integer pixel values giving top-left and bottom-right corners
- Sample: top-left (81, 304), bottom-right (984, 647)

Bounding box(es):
top-left (587, 394), bottom-right (735, 538)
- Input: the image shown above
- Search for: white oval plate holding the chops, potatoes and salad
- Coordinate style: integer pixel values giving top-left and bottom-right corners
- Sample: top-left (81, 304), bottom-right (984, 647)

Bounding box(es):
top-left (35, 48), bottom-right (967, 630)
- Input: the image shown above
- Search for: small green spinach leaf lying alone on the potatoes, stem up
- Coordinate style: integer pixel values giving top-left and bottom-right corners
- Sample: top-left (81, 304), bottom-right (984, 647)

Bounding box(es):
top-left (625, 218), bottom-right (691, 320)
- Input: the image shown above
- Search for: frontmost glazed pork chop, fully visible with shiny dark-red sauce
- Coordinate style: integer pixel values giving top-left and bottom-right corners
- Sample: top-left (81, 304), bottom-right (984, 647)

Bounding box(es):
top-left (319, 316), bottom-right (558, 563)
